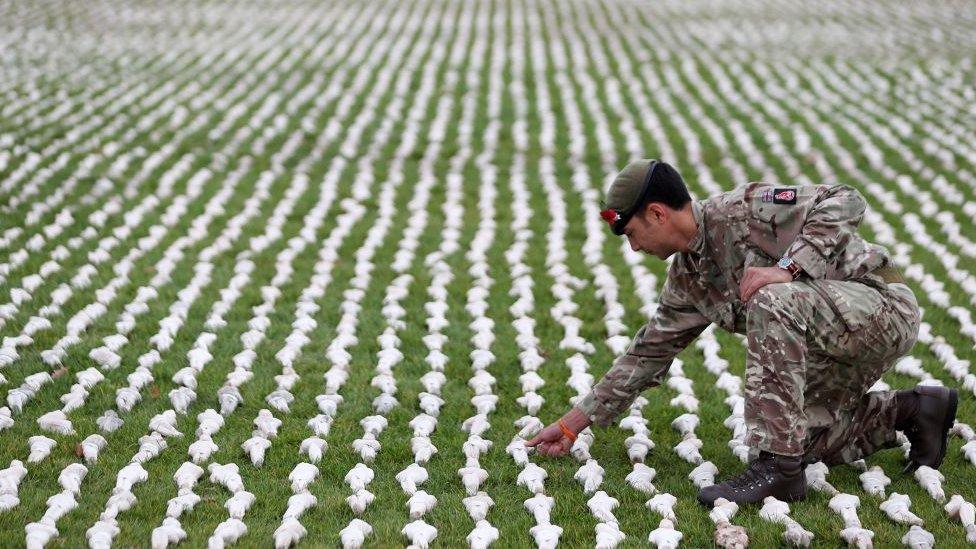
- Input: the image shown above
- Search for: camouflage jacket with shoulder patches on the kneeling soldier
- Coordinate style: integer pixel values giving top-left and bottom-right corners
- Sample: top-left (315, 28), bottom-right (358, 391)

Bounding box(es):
top-left (577, 183), bottom-right (890, 427)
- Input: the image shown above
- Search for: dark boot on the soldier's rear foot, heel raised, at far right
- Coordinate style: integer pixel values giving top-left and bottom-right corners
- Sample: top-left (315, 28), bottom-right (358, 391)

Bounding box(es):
top-left (895, 385), bottom-right (959, 473)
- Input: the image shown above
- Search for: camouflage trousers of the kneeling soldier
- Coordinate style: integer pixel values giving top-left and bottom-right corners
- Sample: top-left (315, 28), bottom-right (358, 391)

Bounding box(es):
top-left (745, 280), bottom-right (921, 465)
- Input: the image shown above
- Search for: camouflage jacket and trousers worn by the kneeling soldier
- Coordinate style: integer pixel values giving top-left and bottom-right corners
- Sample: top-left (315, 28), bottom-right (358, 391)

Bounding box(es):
top-left (578, 183), bottom-right (920, 464)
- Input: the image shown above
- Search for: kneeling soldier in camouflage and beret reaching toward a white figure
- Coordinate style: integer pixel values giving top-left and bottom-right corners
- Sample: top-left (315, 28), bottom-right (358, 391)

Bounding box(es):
top-left (527, 160), bottom-right (957, 506)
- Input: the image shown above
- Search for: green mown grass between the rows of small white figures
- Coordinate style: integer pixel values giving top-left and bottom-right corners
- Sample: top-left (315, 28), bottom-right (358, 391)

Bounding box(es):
top-left (0, 0), bottom-right (976, 547)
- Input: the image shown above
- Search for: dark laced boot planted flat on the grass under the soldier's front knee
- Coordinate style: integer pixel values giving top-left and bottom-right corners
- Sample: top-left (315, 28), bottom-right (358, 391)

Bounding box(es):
top-left (698, 452), bottom-right (807, 507)
